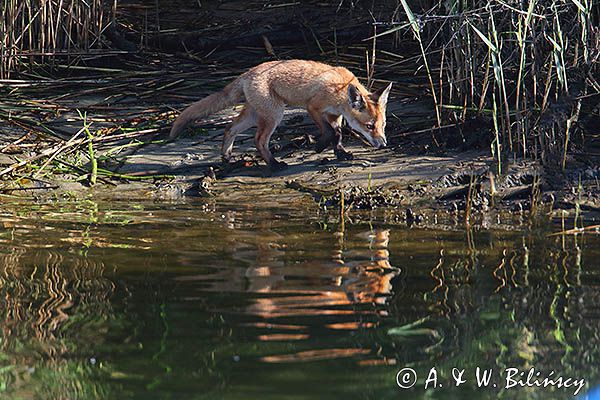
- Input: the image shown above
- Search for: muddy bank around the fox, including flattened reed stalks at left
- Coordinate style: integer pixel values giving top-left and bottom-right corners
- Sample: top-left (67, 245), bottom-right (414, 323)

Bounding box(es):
top-left (0, 70), bottom-right (600, 219)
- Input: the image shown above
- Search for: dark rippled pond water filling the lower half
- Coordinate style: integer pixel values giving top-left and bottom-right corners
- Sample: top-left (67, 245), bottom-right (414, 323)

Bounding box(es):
top-left (0, 201), bottom-right (600, 399)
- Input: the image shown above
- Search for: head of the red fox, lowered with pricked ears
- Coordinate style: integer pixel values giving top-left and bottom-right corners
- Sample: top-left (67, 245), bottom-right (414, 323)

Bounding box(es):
top-left (344, 83), bottom-right (392, 149)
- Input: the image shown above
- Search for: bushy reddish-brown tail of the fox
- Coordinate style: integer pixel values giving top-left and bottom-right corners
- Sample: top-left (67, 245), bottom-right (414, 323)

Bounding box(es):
top-left (169, 78), bottom-right (244, 139)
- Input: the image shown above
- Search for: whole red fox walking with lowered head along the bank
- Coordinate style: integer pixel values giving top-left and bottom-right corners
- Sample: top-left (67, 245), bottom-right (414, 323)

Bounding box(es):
top-left (169, 60), bottom-right (392, 170)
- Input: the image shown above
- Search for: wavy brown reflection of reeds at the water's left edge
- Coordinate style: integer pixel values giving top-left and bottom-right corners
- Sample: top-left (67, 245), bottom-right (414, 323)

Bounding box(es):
top-left (0, 249), bottom-right (114, 348)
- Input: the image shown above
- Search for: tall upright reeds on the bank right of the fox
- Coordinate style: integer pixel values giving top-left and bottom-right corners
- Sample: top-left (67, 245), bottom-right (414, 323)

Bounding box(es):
top-left (402, 0), bottom-right (600, 169)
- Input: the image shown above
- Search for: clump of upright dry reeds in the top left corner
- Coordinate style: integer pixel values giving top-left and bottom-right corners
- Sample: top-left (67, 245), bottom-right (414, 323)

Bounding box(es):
top-left (0, 0), bottom-right (117, 79)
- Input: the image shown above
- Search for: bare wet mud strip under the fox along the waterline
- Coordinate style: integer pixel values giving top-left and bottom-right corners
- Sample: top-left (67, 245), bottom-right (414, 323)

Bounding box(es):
top-left (4, 102), bottom-right (600, 223)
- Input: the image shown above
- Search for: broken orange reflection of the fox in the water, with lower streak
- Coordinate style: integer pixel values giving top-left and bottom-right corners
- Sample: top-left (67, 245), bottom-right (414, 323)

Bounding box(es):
top-left (180, 230), bottom-right (399, 362)
